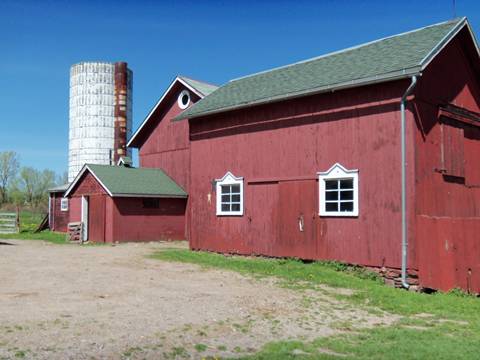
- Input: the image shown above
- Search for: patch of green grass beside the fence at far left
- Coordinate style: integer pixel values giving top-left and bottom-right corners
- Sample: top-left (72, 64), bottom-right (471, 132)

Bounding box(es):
top-left (0, 211), bottom-right (68, 244)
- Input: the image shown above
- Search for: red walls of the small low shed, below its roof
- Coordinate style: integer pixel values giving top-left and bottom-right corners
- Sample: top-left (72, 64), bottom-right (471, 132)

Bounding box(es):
top-left (70, 171), bottom-right (186, 243)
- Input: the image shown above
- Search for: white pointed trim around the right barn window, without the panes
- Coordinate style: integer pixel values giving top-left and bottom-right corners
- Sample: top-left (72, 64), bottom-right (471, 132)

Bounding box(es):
top-left (317, 163), bottom-right (359, 217)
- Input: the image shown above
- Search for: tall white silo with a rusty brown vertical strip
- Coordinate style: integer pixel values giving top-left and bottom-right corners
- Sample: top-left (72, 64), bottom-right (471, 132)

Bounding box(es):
top-left (68, 62), bottom-right (132, 182)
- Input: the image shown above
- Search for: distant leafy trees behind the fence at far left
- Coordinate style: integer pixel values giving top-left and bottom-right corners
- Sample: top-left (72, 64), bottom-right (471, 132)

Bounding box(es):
top-left (0, 151), bottom-right (67, 210)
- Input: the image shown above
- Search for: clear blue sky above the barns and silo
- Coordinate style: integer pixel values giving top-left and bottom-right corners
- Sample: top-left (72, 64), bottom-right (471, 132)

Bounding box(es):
top-left (0, 0), bottom-right (480, 173)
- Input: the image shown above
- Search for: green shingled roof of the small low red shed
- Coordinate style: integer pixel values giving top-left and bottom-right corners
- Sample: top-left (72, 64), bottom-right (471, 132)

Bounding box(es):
top-left (67, 164), bottom-right (187, 198)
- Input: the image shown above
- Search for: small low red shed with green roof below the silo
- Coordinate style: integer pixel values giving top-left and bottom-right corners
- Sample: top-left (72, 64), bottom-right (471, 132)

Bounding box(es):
top-left (65, 164), bottom-right (187, 243)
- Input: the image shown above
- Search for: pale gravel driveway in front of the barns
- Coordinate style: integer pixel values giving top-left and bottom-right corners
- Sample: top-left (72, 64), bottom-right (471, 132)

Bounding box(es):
top-left (0, 240), bottom-right (395, 359)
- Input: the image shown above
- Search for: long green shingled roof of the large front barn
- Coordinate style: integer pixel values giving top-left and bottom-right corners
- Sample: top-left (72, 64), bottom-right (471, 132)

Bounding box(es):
top-left (175, 18), bottom-right (467, 120)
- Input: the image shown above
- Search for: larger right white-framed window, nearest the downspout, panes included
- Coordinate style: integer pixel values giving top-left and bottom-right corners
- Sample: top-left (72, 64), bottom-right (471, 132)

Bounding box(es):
top-left (317, 163), bottom-right (358, 216)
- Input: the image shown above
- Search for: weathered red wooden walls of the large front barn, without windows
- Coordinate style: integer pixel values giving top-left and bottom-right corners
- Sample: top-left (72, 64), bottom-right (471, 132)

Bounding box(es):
top-left (185, 29), bottom-right (480, 292)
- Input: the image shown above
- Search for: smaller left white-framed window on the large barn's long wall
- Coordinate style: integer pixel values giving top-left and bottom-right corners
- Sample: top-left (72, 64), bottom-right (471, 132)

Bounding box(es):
top-left (215, 172), bottom-right (243, 216)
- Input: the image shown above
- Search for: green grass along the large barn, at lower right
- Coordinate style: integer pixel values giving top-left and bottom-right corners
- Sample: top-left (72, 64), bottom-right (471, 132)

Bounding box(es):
top-left (152, 249), bottom-right (480, 359)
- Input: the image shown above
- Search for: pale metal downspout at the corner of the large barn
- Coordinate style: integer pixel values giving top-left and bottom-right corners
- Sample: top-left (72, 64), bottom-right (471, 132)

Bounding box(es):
top-left (400, 75), bottom-right (417, 289)
